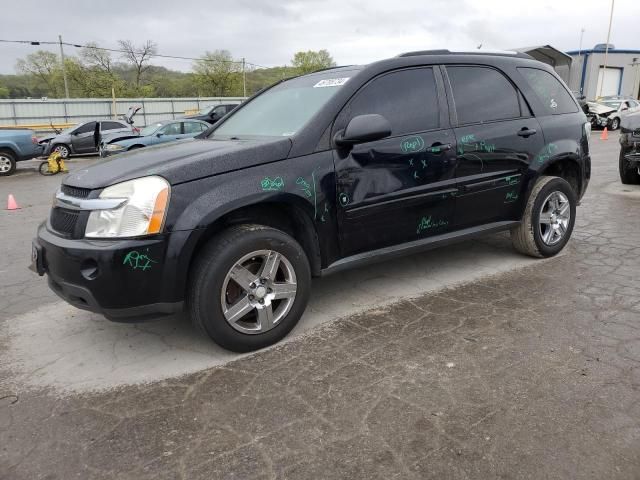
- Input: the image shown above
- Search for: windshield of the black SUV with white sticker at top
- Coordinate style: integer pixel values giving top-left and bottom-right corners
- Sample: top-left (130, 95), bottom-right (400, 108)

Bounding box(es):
top-left (212, 70), bottom-right (356, 138)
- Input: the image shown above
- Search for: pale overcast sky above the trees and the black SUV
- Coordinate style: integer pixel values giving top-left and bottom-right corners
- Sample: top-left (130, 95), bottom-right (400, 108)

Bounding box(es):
top-left (0, 0), bottom-right (640, 73)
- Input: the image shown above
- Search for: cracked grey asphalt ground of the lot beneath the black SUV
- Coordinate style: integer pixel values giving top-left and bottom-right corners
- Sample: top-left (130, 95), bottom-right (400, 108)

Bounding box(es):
top-left (0, 133), bottom-right (640, 479)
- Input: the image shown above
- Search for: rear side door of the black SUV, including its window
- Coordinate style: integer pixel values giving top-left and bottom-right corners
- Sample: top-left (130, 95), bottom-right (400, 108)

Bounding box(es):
top-left (445, 65), bottom-right (544, 228)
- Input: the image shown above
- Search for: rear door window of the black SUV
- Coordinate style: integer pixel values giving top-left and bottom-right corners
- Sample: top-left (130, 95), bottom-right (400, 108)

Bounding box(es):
top-left (447, 67), bottom-right (521, 125)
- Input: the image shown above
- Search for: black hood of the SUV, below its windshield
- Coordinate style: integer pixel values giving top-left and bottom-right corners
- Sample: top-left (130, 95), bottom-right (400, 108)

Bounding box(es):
top-left (64, 138), bottom-right (291, 189)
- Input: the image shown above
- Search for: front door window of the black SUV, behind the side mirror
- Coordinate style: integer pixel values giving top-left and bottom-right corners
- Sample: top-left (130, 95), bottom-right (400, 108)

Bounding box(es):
top-left (345, 68), bottom-right (440, 136)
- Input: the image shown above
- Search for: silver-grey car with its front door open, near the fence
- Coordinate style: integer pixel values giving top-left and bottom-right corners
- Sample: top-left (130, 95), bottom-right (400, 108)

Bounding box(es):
top-left (40, 120), bottom-right (133, 158)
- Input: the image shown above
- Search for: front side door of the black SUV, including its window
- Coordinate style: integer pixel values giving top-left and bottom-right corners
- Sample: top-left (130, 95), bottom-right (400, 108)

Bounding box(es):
top-left (333, 67), bottom-right (455, 255)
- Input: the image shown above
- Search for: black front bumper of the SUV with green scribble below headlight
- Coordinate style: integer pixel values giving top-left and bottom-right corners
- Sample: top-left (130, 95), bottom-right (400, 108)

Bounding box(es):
top-left (32, 223), bottom-right (188, 321)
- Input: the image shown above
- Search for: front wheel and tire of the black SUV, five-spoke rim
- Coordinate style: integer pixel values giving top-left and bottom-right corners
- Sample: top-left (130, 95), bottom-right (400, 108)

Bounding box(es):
top-left (187, 225), bottom-right (311, 352)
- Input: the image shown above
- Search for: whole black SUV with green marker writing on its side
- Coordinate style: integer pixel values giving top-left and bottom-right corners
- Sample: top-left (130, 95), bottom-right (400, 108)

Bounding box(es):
top-left (33, 50), bottom-right (590, 351)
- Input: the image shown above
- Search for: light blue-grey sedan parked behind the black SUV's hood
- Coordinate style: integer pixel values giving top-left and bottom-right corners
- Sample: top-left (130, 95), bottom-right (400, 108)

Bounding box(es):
top-left (100, 120), bottom-right (211, 157)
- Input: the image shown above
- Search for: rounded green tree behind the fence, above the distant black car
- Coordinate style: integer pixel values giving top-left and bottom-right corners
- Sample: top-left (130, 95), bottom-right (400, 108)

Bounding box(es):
top-left (193, 50), bottom-right (242, 97)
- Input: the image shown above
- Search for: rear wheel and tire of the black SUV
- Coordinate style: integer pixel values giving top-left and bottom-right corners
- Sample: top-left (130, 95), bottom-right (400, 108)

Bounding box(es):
top-left (511, 176), bottom-right (577, 257)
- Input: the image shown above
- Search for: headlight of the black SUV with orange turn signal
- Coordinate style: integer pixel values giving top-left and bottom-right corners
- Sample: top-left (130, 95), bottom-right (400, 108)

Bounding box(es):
top-left (84, 177), bottom-right (170, 238)
